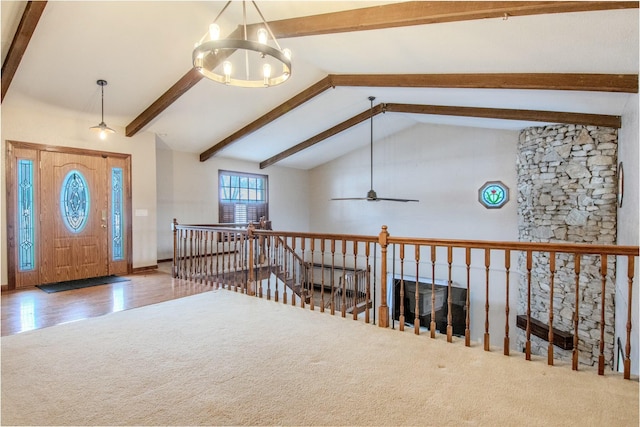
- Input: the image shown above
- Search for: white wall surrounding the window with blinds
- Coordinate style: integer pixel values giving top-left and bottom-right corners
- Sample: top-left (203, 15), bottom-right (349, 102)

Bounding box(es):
top-left (157, 145), bottom-right (309, 259)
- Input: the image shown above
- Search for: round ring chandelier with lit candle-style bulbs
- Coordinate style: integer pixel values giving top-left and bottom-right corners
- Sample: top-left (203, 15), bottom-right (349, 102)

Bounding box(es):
top-left (192, 1), bottom-right (291, 87)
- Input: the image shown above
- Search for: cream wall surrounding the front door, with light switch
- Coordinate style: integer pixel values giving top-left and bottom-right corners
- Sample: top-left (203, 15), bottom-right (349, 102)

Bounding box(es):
top-left (0, 105), bottom-right (157, 285)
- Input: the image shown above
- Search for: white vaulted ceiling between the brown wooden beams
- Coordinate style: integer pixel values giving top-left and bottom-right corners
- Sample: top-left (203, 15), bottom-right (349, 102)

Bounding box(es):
top-left (1, 0), bottom-right (639, 169)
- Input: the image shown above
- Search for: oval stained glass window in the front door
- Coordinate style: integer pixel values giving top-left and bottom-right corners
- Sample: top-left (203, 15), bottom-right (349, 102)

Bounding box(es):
top-left (60, 170), bottom-right (90, 233)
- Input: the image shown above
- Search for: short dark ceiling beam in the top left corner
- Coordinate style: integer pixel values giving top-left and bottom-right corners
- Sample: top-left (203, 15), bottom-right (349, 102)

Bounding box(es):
top-left (0, 1), bottom-right (47, 103)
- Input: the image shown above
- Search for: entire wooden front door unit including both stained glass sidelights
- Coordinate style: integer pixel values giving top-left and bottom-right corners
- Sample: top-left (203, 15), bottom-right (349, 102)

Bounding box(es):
top-left (7, 141), bottom-right (131, 289)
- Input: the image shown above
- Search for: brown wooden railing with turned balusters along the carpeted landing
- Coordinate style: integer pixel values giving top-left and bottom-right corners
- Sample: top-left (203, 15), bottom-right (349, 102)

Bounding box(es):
top-left (173, 223), bottom-right (639, 379)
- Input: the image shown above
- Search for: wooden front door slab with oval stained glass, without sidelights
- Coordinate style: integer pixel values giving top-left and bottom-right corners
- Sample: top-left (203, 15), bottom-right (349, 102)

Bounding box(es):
top-left (40, 151), bottom-right (109, 283)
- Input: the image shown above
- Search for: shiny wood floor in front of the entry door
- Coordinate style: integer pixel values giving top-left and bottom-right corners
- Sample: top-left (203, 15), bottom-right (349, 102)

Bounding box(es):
top-left (0, 265), bottom-right (212, 336)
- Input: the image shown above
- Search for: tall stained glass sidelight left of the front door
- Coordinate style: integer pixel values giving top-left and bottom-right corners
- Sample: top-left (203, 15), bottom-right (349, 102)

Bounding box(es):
top-left (18, 159), bottom-right (36, 271)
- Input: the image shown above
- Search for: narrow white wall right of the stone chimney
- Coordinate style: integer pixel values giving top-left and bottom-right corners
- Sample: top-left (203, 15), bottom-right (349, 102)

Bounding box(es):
top-left (615, 94), bottom-right (640, 375)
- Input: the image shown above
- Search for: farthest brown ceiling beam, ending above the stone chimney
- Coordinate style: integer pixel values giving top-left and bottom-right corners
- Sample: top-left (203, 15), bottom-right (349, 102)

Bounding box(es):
top-left (260, 103), bottom-right (621, 169)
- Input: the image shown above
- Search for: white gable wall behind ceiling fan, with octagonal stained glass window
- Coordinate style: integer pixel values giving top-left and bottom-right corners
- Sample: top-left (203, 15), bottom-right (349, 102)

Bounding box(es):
top-left (310, 125), bottom-right (518, 345)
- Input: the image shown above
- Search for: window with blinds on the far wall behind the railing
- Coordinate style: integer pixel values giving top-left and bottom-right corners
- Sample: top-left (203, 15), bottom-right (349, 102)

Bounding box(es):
top-left (218, 170), bottom-right (269, 223)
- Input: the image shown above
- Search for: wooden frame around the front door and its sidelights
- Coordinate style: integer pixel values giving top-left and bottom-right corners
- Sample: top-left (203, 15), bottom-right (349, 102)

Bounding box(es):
top-left (5, 140), bottom-right (133, 290)
